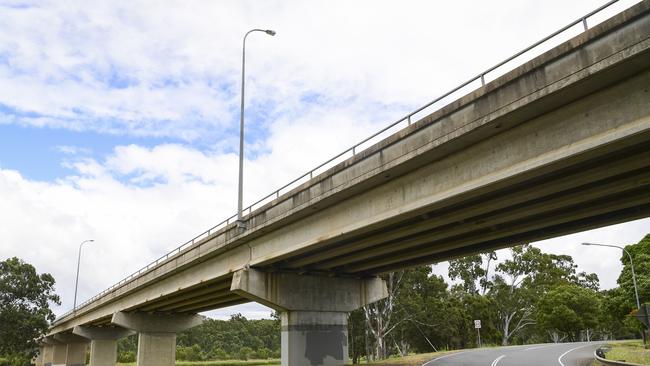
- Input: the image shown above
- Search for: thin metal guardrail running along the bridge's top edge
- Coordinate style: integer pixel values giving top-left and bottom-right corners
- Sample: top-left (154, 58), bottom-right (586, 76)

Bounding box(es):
top-left (54, 0), bottom-right (620, 323)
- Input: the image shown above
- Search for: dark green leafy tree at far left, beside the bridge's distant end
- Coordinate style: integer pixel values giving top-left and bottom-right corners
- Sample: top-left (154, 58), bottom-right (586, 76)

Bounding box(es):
top-left (0, 257), bottom-right (60, 365)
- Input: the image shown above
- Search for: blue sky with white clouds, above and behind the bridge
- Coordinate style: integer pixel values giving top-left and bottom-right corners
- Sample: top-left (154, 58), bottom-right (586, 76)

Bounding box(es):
top-left (0, 0), bottom-right (650, 318)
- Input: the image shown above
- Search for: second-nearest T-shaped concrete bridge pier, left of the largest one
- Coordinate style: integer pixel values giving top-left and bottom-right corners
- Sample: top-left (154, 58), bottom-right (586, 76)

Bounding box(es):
top-left (111, 312), bottom-right (204, 366)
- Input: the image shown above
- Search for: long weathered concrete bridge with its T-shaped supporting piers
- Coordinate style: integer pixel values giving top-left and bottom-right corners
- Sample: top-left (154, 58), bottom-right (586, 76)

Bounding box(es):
top-left (38, 0), bottom-right (650, 366)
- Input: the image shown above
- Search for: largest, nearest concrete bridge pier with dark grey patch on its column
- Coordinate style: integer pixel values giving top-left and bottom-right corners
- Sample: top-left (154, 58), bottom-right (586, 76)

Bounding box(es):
top-left (230, 269), bottom-right (388, 366)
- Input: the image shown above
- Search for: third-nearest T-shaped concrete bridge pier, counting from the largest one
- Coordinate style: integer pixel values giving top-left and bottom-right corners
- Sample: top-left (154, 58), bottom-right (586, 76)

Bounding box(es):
top-left (72, 326), bottom-right (135, 366)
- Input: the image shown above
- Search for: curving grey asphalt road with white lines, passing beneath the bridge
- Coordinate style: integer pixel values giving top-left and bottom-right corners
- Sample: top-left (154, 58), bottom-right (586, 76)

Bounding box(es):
top-left (423, 342), bottom-right (602, 366)
